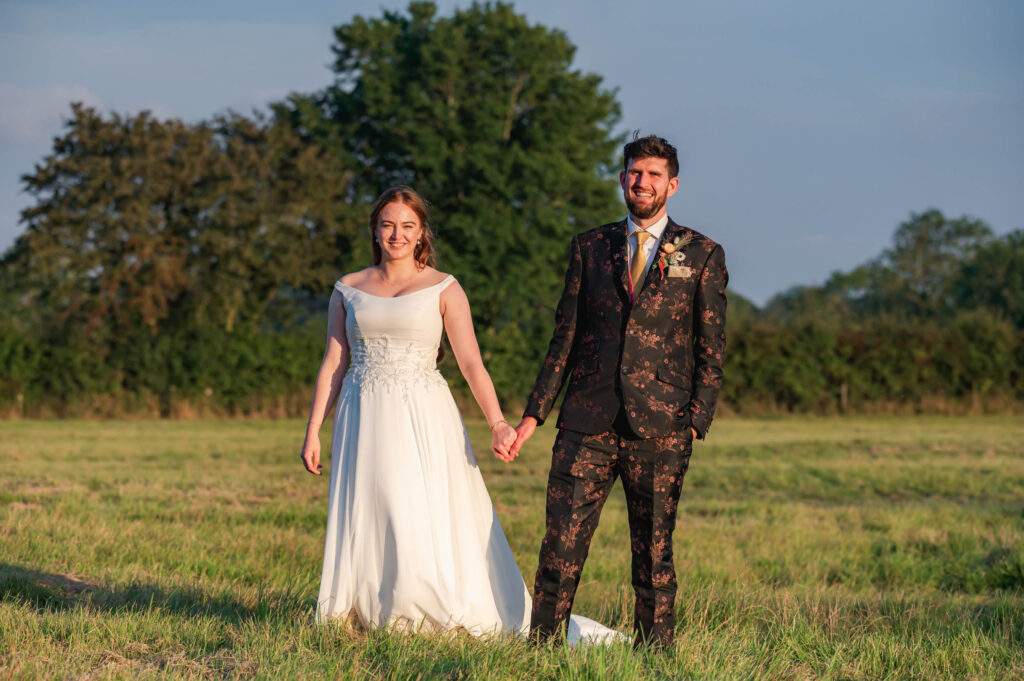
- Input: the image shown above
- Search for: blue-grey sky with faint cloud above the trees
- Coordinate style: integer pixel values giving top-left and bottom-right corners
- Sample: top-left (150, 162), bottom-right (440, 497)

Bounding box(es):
top-left (0, 0), bottom-right (1024, 303)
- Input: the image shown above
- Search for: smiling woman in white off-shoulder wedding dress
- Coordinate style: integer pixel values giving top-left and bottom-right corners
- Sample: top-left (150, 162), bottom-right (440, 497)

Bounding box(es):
top-left (301, 186), bottom-right (622, 642)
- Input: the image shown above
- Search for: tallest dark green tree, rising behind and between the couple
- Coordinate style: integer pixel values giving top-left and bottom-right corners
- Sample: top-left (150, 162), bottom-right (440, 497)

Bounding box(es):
top-left (276, 2), bottom-right (622, 398)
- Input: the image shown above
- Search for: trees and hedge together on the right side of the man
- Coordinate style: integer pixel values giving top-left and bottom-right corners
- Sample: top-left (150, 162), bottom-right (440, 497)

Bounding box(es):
top-left (725, 210), bottom-right (1024, 413)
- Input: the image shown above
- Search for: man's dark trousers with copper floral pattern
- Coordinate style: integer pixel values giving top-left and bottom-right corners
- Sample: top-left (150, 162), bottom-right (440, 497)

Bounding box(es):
top-left (530, 415), bottom-right (693, 646)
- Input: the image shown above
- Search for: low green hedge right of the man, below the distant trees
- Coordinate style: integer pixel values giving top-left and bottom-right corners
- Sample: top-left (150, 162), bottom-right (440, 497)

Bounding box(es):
top-left (724, 309), bottom-right (1024, 414)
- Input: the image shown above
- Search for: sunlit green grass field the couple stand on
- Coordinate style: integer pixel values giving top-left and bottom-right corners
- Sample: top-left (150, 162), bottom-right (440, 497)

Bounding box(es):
top-left (0, 418), bottom-right (1024, 681)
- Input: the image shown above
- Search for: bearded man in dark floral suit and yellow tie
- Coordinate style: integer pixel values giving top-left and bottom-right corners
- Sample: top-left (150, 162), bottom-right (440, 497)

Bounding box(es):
top-left (513, 135), bottom-right (729, 645)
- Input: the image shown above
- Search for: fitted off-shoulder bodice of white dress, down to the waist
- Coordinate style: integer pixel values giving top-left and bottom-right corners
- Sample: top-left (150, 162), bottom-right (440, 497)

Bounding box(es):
top-left (334, 274), bottom-right (455, 387)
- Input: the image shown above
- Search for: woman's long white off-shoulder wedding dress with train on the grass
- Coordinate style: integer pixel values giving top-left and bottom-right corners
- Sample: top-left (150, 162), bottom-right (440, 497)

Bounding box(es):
top-left (316, 276), bottom-right (625, 643)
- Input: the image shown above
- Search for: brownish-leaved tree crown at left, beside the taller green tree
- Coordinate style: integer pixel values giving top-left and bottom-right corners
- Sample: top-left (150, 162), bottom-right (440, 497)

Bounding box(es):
top-left (4, 104), bottom-right (356, 331)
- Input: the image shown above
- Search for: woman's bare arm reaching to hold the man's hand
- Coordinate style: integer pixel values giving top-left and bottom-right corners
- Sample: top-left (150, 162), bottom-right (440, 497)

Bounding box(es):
top-left (441, 282), bottom-right (515, 461)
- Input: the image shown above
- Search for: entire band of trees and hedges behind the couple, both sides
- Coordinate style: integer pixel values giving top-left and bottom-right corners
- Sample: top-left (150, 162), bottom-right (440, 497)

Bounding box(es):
top-left (0, 3), bottom-right (1024, 417)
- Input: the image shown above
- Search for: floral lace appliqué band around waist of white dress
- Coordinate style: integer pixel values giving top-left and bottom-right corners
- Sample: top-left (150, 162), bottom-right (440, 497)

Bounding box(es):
top-left (344, 336), bottom-right (447, 392)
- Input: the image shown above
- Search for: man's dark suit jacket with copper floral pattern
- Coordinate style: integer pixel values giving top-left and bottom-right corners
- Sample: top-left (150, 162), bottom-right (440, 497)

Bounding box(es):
top-left (524, 219), bottom-right (729, 438)
